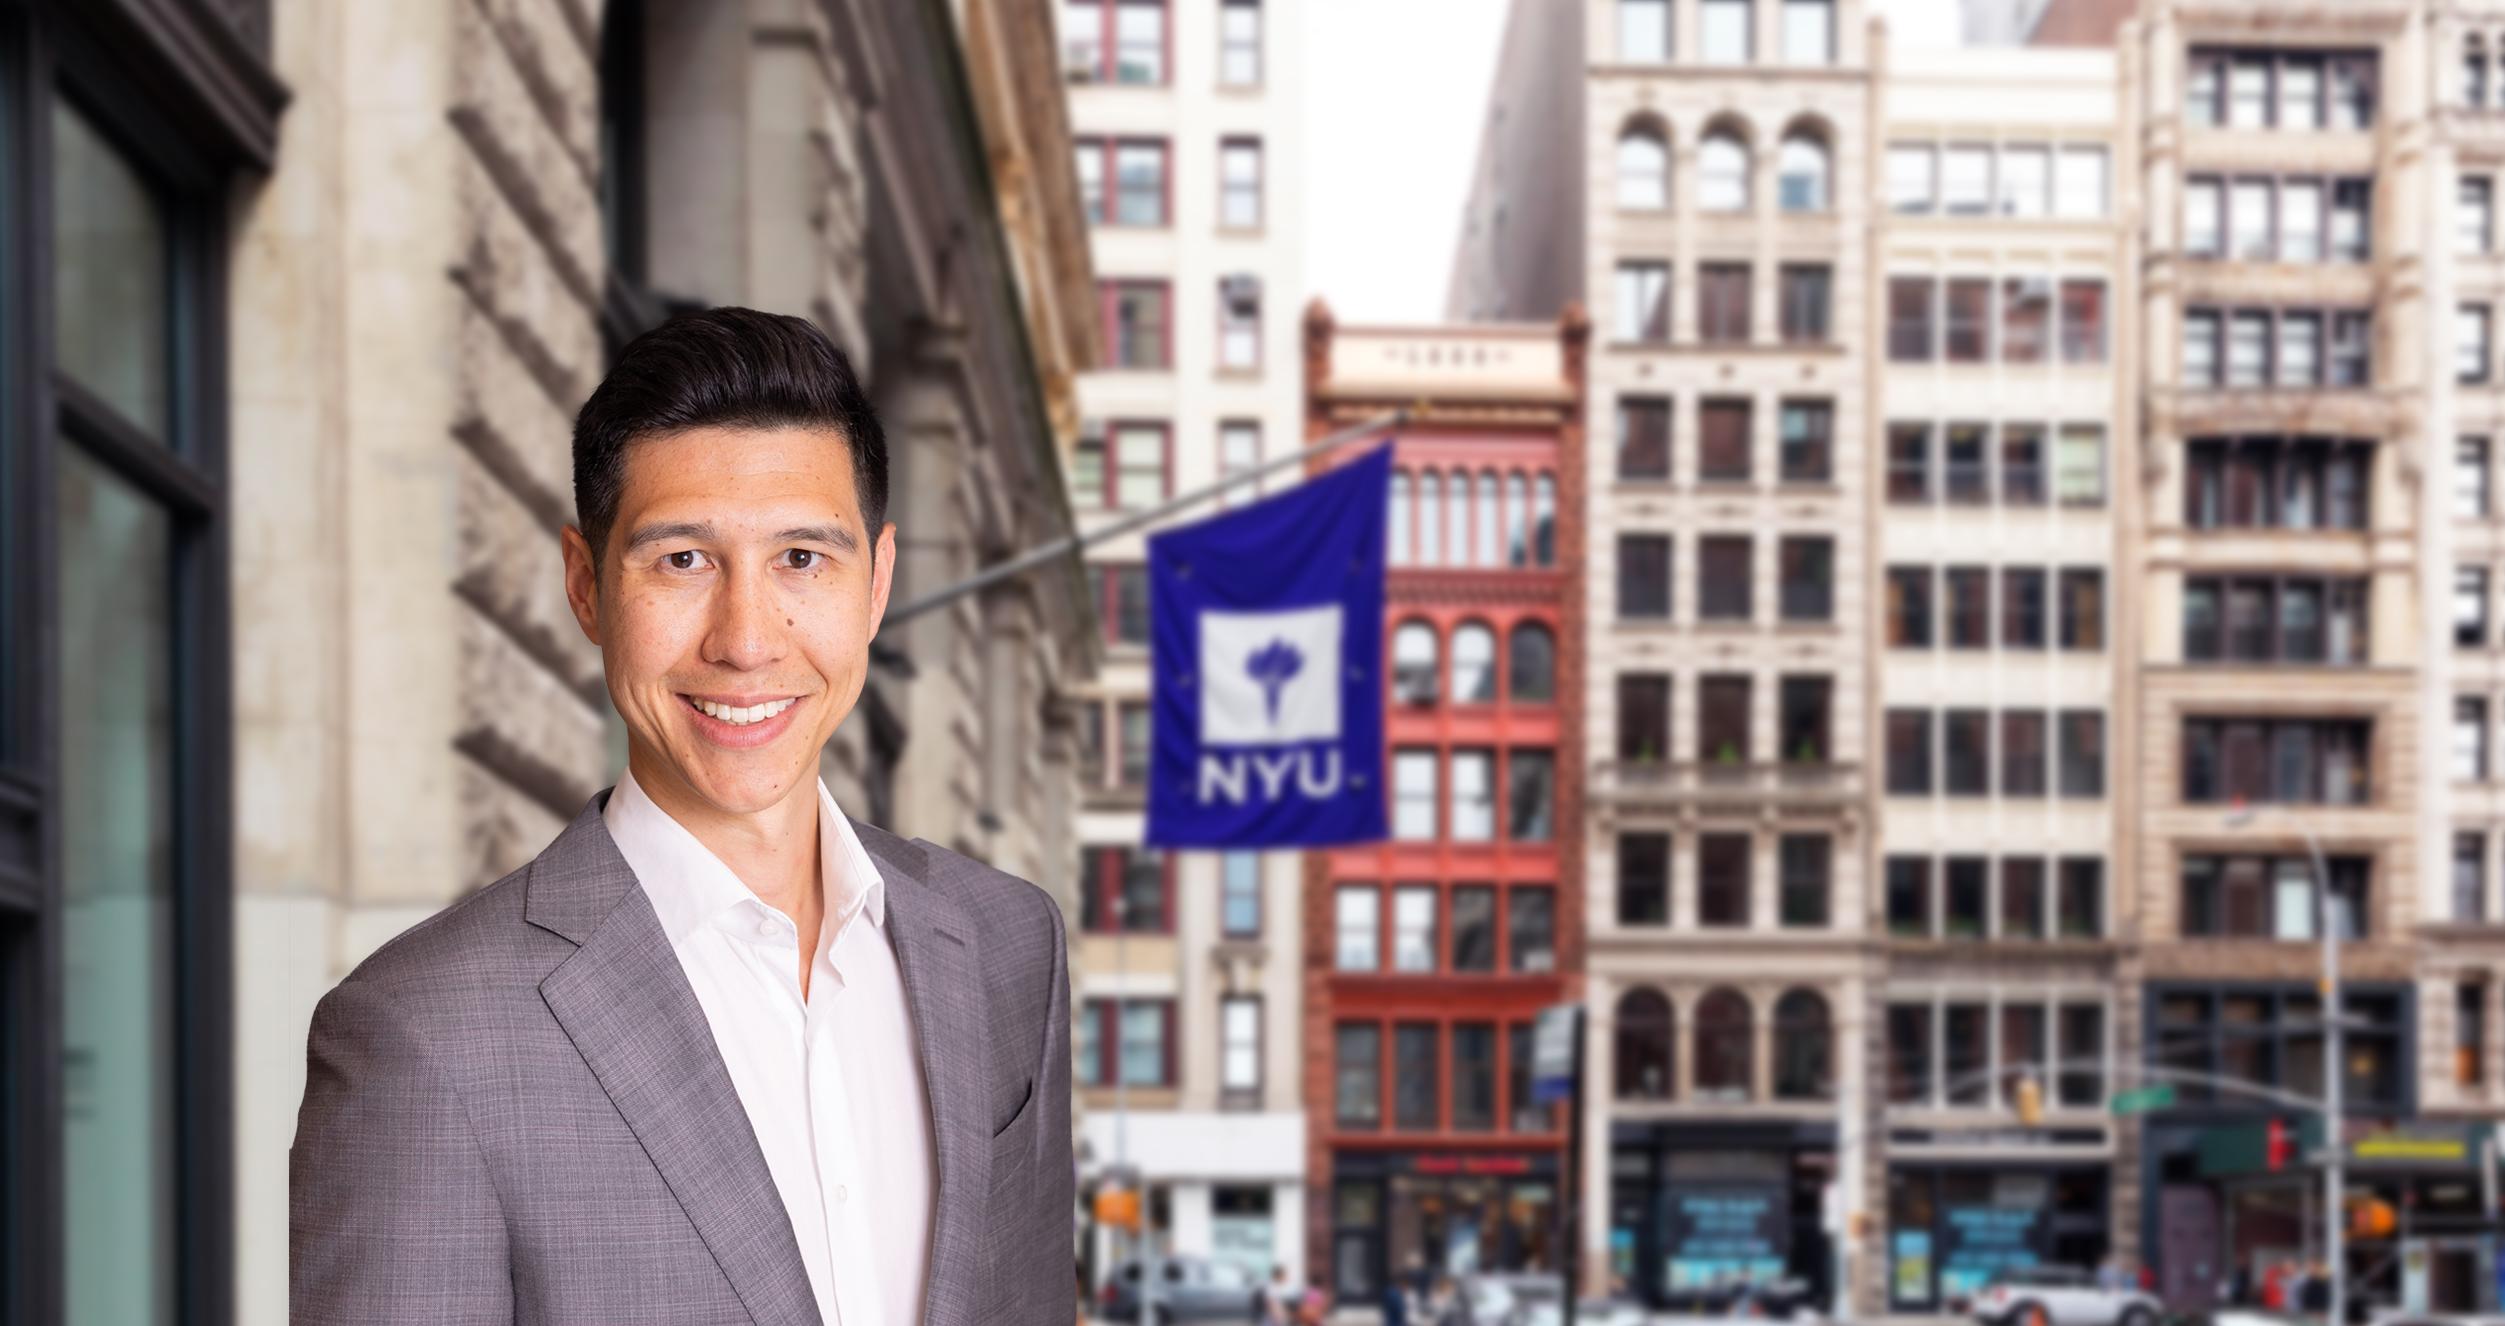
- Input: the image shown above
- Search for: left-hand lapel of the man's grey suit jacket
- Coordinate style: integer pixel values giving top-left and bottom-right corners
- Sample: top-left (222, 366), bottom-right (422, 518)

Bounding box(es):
top-left (526, 792), bottom-right (819, 1326)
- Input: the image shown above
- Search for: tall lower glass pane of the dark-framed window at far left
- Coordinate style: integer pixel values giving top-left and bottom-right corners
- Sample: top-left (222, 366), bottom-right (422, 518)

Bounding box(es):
top-left (58, 446), bottom-right (175, 1323)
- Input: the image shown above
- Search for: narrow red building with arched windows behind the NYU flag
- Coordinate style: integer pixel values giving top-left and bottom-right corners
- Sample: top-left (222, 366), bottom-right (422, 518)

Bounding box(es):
top-left (1303, 303), bottom-right (1588, 1303)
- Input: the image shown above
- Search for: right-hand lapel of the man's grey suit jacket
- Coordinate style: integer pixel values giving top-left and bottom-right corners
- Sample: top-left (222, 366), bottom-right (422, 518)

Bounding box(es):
top-left (852, 820), bottom-right (992, 1326)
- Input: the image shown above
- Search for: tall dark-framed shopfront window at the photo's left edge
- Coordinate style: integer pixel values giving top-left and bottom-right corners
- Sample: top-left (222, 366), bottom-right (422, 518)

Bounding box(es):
top-left (0, 3), bottom-right (283, 1326)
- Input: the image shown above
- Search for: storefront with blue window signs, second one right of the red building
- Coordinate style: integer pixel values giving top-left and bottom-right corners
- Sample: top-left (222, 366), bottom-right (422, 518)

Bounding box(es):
top-left (1886, 1161), bottom-right (2112, 1313)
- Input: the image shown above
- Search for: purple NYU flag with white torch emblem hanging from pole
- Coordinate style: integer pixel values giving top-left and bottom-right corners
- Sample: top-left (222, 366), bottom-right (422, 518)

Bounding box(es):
top-left (1147, 444), bottom-right (1390, 847)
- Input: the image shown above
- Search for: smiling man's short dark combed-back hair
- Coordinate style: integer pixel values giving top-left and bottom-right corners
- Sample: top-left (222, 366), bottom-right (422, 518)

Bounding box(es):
top-left (574, 306), bottom-right (887, 569)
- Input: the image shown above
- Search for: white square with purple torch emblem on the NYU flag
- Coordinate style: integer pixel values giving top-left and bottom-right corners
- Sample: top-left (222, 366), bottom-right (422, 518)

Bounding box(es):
top-left (1200, 604), bottom-right (1340, 747)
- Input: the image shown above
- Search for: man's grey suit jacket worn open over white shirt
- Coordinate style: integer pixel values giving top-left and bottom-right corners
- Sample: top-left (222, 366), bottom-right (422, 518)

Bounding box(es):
top-left (288, 792), bottom-right (1075, 1326)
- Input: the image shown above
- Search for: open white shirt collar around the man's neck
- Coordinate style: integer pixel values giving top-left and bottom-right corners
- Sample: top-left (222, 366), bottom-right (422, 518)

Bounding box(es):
top-left (601, 770), bottom-right (887, 945)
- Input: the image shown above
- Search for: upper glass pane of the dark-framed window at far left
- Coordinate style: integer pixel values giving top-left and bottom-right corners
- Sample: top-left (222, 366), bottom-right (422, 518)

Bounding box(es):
top-left (53, 103), bottom-right (173, 441)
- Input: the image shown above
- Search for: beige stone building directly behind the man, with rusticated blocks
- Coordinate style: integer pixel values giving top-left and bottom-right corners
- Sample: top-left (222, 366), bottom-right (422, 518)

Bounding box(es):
top-left (14, 0), bottom-right (1102, 1323)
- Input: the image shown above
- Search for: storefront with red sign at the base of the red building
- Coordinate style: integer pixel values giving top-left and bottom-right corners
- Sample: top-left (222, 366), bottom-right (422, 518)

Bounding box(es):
top-left (1330, 1151), bottom-right (1558, 1301)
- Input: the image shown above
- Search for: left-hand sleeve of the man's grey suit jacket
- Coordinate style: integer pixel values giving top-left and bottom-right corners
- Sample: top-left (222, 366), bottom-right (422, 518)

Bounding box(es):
top-left (288, 980), bottom-right (514, 1326)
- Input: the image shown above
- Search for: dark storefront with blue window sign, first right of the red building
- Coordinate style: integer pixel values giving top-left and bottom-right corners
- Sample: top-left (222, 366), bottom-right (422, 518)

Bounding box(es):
top-left (1608, 1123), bottom-right (1836, 1308)
